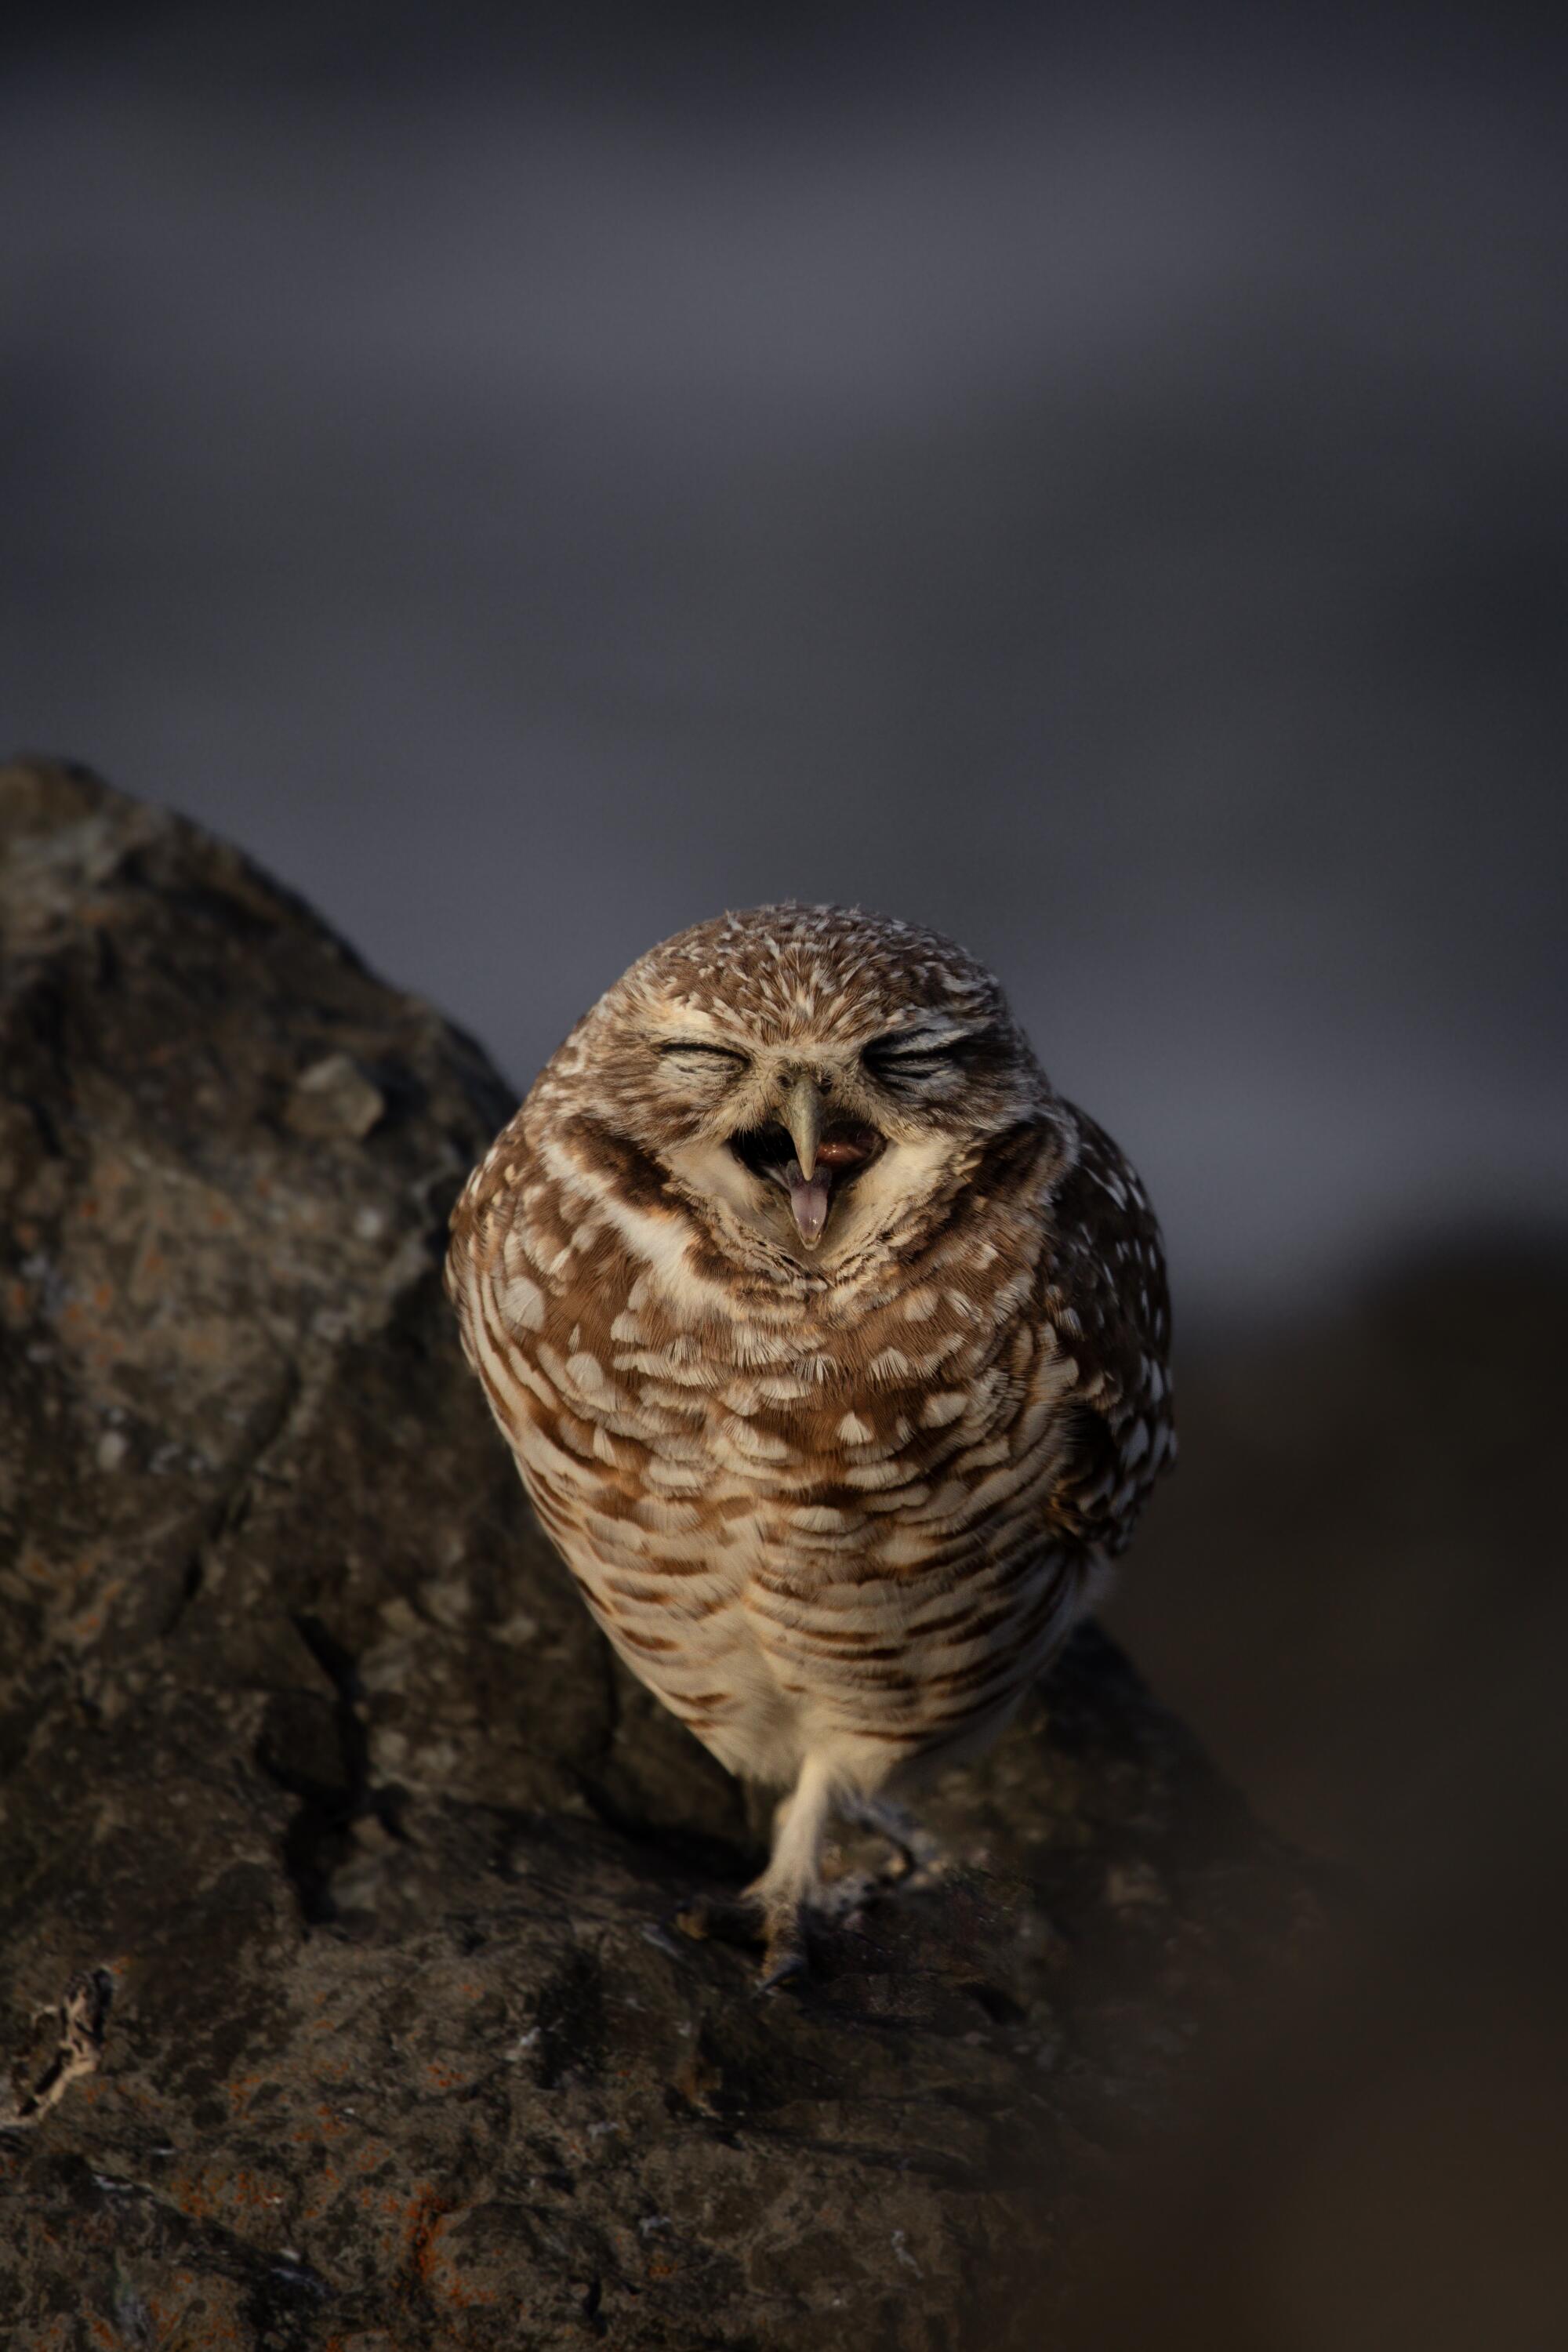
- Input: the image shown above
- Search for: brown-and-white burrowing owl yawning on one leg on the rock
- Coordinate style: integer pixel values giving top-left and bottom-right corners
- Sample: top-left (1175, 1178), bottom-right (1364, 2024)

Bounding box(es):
top-left (447, 906), bottom-right (1173, 1983)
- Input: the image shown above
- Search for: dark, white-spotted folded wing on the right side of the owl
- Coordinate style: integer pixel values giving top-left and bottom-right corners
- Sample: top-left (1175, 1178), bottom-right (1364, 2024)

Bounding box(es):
top-left (1041, 1110), bottom-right (1175, 1552)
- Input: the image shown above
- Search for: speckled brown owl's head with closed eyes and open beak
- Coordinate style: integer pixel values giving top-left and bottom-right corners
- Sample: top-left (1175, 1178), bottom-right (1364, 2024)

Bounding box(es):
top-left (557, 903), bottom-right (1055, 1270)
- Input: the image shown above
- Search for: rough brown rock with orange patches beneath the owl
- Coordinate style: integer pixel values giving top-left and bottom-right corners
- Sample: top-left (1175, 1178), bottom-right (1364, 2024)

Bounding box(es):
top-left (0, 767), bottom-right (1312, 2352)
